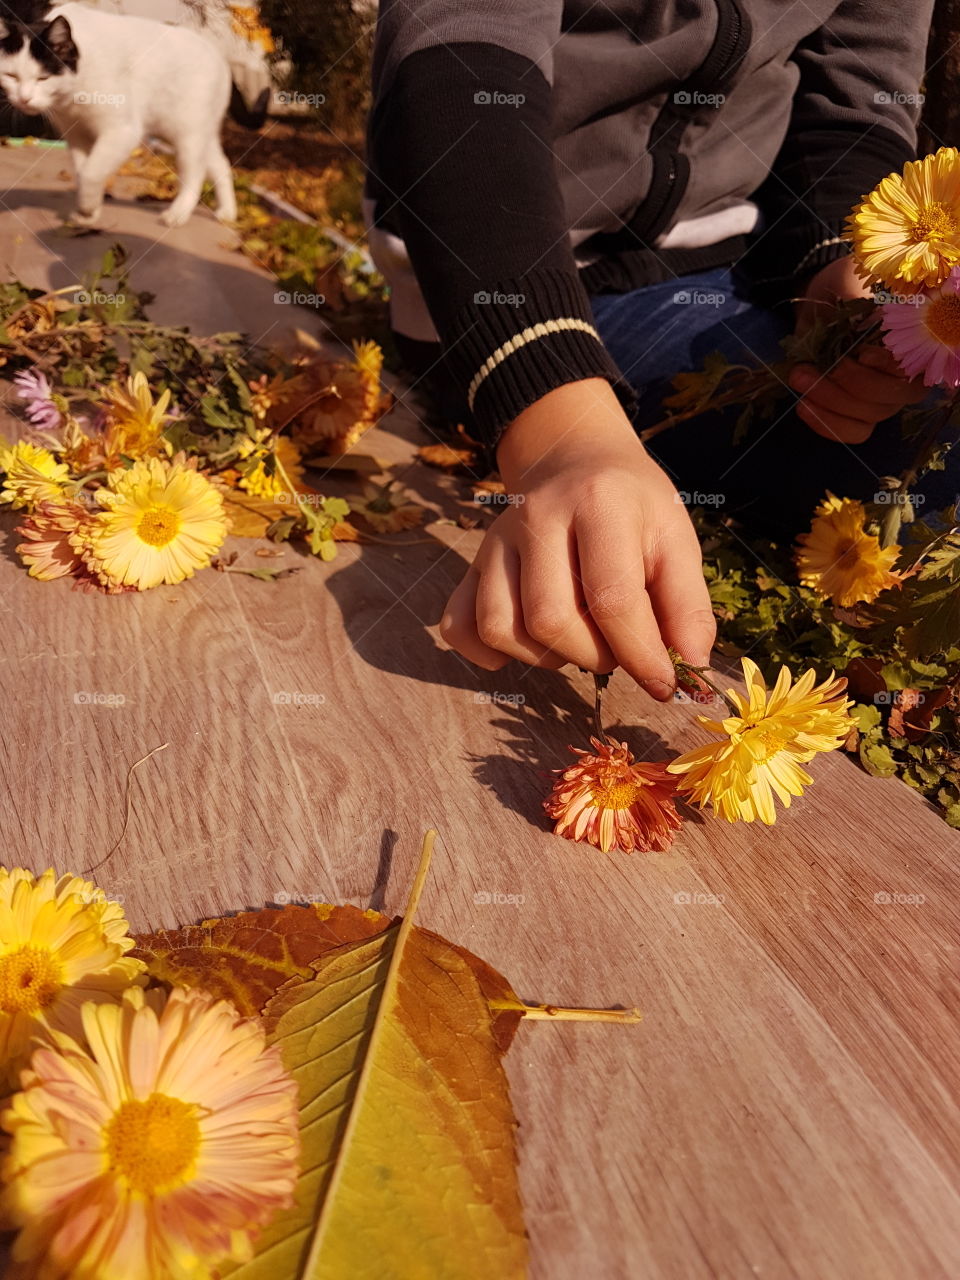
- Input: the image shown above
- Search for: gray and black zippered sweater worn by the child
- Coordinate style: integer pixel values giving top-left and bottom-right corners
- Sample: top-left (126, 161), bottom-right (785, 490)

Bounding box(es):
top-left (367, 0), bottom-right (932, 442)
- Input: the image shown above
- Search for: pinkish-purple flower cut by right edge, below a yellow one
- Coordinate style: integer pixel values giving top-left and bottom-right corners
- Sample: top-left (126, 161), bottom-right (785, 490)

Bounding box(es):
top-left (881, 268), bottom-right (960, 388)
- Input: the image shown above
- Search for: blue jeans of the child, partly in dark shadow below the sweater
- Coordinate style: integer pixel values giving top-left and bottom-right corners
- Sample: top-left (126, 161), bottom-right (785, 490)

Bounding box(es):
top-left (593, 268), bottom-right (960, 539)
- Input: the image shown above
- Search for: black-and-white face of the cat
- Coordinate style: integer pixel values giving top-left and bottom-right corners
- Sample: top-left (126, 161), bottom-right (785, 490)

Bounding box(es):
top-left (0, 17), bottom-right (79, 115)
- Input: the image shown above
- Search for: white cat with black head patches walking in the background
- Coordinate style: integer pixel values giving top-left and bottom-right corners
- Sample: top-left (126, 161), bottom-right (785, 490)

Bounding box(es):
top-left (0, 0), bottom-right (237, 227)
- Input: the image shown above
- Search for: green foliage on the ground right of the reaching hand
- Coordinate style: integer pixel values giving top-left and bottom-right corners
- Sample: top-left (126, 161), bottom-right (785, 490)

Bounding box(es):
top-left (694, 511), bottom-right (960, 827)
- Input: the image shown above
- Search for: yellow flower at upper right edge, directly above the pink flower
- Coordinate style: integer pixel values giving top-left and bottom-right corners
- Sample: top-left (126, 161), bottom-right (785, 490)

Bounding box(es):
top-left (847, 147), bottom-right (960, 291)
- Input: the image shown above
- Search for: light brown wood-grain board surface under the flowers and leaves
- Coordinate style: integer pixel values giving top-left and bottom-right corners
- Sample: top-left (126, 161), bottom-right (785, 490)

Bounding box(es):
top-left (0, 145), bottom-right (960, 1280)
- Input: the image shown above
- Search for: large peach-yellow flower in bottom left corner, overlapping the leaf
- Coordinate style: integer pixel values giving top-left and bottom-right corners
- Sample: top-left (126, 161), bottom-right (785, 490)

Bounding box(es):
top-left (3, 988), bottom-right (298, 1280)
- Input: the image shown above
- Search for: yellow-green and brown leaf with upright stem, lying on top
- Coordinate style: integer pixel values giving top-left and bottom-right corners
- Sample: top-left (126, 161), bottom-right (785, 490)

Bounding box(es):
top-left (221, 832), bottom-right (526, 1280)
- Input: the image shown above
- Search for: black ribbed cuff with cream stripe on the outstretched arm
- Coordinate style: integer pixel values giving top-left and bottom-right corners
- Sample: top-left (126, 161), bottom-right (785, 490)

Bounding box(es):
top-left (447, 270), bottom-right (636, 445)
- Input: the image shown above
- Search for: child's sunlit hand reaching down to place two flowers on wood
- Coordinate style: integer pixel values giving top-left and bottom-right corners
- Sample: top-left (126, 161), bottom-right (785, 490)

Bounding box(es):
top-left (440, 379), bottom-right (716, 700)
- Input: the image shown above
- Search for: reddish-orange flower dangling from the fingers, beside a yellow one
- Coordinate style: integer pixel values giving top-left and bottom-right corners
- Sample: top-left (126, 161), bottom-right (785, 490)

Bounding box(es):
top-left (544, 737), bottom-right (680, 854)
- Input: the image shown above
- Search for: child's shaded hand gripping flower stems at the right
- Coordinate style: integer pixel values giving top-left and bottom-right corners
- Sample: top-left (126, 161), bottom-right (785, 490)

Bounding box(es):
top-left (790, 256), bottom-right (927, 444)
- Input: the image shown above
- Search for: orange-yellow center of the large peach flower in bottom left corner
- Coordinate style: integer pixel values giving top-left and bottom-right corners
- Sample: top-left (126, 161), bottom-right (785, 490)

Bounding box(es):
top-left (104, 1093), bottom-right (200, 1196)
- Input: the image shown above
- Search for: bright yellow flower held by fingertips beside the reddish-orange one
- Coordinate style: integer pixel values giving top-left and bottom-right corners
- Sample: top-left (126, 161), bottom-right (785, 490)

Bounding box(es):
top-left (668, 658), bottom-right (852, 826)
